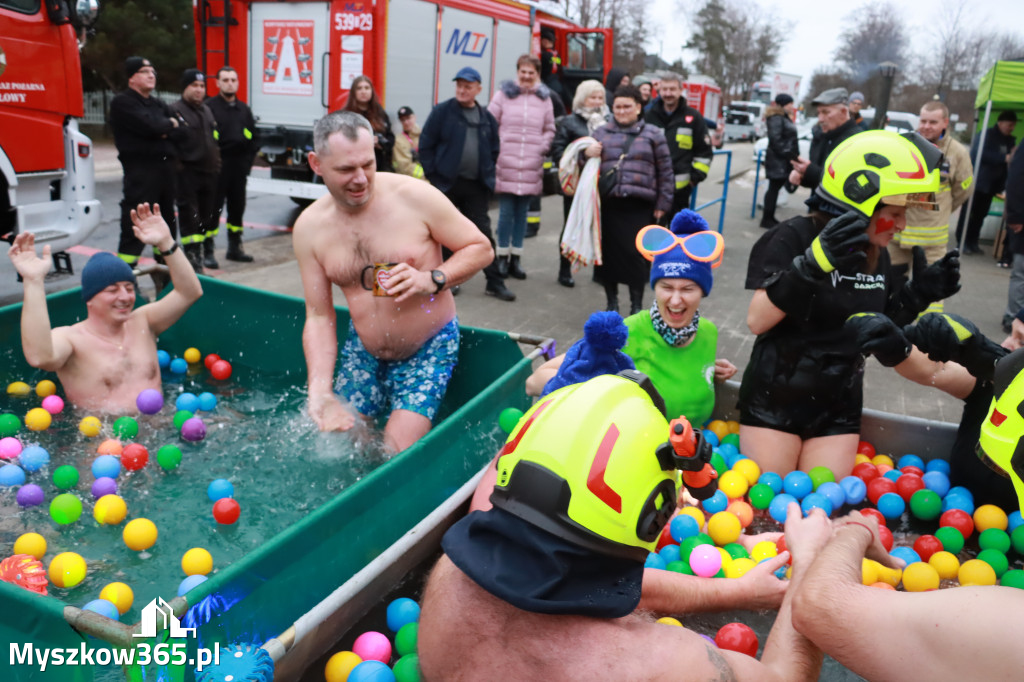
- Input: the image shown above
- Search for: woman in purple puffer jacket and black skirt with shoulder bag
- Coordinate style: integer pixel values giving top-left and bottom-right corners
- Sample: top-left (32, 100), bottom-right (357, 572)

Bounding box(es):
top-left (584, 85), bottom-right (675, 315)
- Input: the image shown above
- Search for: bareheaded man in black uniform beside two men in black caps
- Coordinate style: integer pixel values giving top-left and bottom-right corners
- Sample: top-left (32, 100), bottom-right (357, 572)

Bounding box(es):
top-left (205, 67), bottom-right (259, 267)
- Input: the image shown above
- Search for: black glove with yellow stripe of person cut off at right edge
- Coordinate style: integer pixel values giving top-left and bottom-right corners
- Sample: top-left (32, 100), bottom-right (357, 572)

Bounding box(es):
top-left (904, 312), bottom-right (1010, 381)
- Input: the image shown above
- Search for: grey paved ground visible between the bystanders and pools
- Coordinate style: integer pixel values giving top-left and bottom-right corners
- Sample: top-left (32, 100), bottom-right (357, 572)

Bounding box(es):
top-left (9, 143), bottom-right (1009, 421)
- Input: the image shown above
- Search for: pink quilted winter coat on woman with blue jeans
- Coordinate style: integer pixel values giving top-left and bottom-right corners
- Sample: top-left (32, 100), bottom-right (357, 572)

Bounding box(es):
top-left (487, 81), bottom-right (555, 197)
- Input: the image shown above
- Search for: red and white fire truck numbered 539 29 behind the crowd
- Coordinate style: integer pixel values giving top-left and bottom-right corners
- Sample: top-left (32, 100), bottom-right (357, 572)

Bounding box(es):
top-left (193, 0), bottom-right (612, 196)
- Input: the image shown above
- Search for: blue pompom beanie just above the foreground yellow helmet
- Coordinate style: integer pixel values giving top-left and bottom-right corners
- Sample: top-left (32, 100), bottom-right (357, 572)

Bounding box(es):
top-left (541, 310), bottom-right (636, 396)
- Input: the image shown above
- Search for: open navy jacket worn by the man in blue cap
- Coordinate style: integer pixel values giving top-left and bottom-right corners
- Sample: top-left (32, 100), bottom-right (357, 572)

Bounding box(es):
top-left (420, 97), bottom-right (501, 191)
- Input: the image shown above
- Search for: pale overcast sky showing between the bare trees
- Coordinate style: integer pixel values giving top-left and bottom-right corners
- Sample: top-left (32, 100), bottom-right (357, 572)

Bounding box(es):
top-left (647, 0), bottom-right (1024, 97)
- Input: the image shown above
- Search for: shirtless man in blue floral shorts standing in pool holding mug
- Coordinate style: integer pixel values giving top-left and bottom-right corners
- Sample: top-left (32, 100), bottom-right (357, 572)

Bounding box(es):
top-left (293, 112), bottom-right (494, 452)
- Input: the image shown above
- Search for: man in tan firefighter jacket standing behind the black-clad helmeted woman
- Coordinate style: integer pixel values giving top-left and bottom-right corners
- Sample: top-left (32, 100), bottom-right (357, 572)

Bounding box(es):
top-left (889, 101), bottom-right (974, 312)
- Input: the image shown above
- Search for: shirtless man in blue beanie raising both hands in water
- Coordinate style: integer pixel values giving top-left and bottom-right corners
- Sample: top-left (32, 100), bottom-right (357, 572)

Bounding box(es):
top-left (7, 204), bottom-right (203, 413)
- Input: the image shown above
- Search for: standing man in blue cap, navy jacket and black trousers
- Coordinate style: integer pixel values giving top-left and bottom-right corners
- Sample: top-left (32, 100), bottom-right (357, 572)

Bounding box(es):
top-left (420, 67), bottom-right (515, 301)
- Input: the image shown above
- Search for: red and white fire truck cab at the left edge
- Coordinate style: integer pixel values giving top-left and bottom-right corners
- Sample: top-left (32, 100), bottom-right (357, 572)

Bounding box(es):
top-left (0, 0), bottom-right (100, 260)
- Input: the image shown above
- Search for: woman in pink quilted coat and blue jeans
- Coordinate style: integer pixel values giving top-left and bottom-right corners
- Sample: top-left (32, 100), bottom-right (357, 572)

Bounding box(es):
top-left (487, 54), bottom-right (555, 280)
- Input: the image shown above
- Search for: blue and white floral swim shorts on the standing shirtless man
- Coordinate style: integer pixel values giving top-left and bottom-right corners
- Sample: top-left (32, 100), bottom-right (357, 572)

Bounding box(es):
top-left (334, 317), bottom-right (459, 421)
